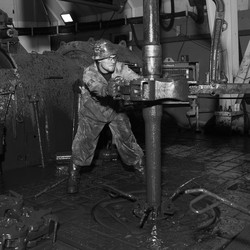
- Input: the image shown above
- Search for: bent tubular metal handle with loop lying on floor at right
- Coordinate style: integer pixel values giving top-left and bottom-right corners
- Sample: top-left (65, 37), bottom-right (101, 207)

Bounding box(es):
top-left (185, 188), bottom-right (250, 215)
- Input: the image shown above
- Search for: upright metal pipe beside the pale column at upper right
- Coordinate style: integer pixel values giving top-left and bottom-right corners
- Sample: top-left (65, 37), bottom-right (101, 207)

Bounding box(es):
top-left (209, 0), bottom-right (225, 83)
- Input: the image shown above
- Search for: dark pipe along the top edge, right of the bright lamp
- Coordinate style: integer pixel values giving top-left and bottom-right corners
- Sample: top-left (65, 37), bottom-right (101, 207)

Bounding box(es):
top-left (60, 0), bottom-right (127, 12)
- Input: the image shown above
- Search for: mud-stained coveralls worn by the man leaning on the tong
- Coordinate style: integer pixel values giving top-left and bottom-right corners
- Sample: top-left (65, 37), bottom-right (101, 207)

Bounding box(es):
top-left (68, 62), bottom-right (144, 193)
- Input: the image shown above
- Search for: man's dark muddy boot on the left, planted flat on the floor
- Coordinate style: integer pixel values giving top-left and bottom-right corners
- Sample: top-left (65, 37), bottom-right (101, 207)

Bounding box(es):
top-left (67, 163), bottom-right (81, 194)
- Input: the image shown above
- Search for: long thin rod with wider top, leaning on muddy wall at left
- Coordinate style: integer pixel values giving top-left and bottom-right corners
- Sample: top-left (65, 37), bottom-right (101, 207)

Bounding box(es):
top-left (28, 95), bottom-right (45, 168)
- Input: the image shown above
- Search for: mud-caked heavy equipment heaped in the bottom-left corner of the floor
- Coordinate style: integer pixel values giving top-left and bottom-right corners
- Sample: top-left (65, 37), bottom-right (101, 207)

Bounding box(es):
top-left (0, 191), bottom-right (58, 250)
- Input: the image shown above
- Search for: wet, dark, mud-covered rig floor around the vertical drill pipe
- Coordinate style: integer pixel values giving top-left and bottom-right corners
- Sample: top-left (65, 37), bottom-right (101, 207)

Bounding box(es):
top-left (2, 124), bottom-right (250, 250)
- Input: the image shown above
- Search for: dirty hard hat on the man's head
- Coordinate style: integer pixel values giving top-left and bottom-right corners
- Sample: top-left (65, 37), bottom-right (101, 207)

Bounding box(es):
top-left (92, 39), bottom-right (117, 60)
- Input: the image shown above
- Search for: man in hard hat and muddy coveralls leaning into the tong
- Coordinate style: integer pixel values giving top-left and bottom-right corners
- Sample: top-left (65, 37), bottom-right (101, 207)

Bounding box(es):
top-left (67, 39), bottom-right (144, 194)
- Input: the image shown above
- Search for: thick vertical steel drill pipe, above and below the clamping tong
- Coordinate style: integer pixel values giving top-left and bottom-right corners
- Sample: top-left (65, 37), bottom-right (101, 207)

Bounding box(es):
top-left (142, 0), bottom-right (162, 215)
